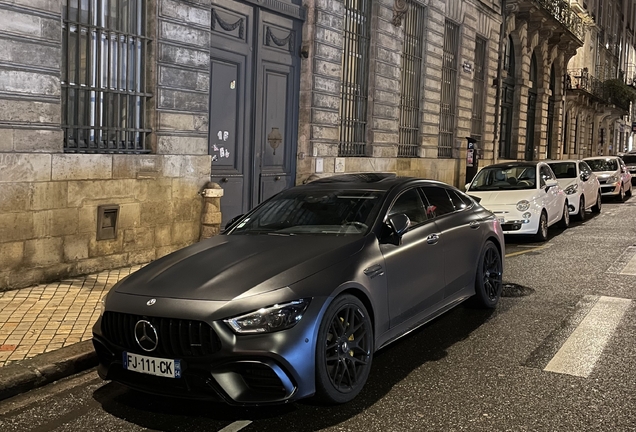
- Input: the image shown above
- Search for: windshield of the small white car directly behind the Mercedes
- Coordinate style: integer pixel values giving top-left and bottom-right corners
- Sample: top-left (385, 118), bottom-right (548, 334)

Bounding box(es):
top-left (468, 165), bottom-right (536, 191)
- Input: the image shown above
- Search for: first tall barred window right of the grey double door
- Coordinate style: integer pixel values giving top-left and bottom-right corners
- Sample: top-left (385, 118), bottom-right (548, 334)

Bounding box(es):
top-left (338, 0), bottom-right (371, 156)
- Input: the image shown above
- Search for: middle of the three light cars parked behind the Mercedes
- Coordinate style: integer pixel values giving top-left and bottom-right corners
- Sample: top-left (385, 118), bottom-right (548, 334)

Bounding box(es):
top-left (545, 160), bottom-right (601, 221)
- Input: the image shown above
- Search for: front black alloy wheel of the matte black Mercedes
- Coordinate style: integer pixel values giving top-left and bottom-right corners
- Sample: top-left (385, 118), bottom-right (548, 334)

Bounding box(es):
top-left (316, 294), bottom-right (373, 404)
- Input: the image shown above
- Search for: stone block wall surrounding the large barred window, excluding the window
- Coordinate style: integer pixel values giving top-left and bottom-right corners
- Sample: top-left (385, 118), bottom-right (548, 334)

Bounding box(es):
top-left (0, 0), bottom-right (218, 290)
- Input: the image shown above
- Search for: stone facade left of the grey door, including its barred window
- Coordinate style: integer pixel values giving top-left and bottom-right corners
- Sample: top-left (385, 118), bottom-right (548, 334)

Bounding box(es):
top-left (0, 0), bottom-right (216, 289)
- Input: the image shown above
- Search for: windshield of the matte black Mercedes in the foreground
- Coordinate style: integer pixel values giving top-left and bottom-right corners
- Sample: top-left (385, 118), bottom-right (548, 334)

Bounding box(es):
top-left (229, 188), bottom-right (384, 235)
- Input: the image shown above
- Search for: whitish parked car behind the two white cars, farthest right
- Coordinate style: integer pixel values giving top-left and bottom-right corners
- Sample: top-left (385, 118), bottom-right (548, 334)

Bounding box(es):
top-left (583, 156), bottom-right (632, 202)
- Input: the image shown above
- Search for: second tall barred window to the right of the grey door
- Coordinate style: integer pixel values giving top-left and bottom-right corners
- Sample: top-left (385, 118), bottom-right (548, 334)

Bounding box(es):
top-left (398, 3), bottom-right (424, 157)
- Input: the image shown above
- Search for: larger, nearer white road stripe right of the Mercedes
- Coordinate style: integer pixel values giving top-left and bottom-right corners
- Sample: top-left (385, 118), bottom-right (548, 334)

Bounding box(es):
top-left (544, 297), bottom-right (631, 378)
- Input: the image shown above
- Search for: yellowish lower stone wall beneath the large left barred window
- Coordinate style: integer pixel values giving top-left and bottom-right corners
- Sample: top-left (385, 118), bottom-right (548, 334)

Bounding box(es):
top-left (0, 153), bottom-right (210, 290)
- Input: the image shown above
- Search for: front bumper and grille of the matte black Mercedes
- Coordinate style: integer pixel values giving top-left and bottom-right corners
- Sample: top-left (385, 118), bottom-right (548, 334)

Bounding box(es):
top-left (93, 298), bottom-right (325, 405)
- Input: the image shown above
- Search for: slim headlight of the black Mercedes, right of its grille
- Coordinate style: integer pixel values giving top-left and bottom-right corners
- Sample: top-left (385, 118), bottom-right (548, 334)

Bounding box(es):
top-left (224, 299), bottom-right (310, 334)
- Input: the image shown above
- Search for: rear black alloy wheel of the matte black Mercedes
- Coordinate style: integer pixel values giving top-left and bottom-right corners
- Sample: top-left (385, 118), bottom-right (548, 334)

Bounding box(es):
top-left (473, 241), bottom-right (503, 309)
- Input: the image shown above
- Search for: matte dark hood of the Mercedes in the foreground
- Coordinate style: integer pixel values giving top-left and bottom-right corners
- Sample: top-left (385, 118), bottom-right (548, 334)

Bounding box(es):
top-left (114, 235), bottom-right (365, 301)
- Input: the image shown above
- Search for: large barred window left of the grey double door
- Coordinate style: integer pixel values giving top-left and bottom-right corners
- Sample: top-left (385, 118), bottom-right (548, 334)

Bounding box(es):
top-left (62, 0), bottom-right (150, 153)
